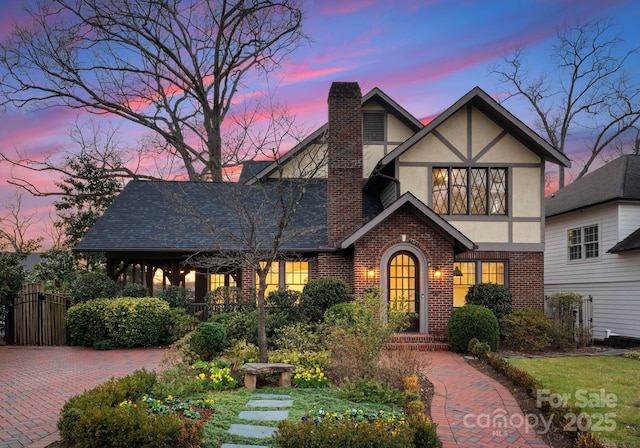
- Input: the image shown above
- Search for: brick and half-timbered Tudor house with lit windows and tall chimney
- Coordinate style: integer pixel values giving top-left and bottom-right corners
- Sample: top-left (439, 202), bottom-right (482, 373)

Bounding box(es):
top-left (75, 82), bottom-right (570, 340)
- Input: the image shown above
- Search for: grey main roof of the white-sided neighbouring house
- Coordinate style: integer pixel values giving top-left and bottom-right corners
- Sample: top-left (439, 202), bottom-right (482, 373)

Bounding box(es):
top-left (545, 154), bottom-right (640, 218)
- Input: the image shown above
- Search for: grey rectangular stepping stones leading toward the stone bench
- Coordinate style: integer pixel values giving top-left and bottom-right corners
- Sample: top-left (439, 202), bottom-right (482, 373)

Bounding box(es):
top-left (222, 393), bottom-right (293, 448)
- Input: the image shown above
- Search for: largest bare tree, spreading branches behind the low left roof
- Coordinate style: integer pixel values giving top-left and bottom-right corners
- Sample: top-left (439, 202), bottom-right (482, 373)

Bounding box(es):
top-left (0, 0), bottom-right (306, 181)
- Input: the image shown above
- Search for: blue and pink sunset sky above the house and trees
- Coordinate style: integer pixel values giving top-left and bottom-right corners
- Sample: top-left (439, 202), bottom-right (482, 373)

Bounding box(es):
top-left (0, 0), bottom-right (640, 248)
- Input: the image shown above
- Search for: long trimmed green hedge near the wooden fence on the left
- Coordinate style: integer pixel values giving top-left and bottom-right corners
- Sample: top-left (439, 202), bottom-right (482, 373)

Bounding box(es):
top-left (67, 297), bottom-right (175, 347)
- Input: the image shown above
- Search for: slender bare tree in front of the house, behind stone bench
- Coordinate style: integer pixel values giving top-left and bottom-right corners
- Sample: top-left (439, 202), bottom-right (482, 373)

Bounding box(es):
top-left (172, 100), bottom-right (326, 362)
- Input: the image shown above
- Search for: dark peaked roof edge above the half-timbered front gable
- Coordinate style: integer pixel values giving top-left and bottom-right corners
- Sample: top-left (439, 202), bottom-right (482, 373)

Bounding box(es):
top-left (378, 87), bottom-right (571, 167)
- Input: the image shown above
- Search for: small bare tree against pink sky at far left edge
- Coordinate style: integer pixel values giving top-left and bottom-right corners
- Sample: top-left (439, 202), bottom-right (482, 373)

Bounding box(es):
top-left (0, 192), bottom-right (44, 256)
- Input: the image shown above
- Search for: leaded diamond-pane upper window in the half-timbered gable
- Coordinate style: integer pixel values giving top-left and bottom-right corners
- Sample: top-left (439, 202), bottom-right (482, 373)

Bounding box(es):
top-left (431, 168), bottom-right (507, 215)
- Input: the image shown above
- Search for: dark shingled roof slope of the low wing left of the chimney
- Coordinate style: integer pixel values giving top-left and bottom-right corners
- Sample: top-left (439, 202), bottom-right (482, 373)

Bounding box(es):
top-left (74, 180), bottom-right (327, 253)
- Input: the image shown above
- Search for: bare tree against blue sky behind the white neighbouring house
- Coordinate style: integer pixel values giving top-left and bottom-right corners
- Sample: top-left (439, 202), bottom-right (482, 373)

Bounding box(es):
top-left (490, 21), bottom-right (640, 188)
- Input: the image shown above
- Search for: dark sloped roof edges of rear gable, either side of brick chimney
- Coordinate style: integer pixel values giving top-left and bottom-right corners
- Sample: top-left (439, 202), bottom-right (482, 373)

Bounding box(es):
top-left (247, 87), bottom-right (424, 184)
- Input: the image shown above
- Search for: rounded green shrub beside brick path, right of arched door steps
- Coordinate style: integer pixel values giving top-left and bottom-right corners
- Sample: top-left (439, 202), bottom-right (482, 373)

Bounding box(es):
top-left (448, 305), bottom-right (500, 353)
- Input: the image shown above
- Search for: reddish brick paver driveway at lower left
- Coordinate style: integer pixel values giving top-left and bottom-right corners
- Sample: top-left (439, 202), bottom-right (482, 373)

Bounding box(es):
top-left (0, 346), bottom-right (166, 448)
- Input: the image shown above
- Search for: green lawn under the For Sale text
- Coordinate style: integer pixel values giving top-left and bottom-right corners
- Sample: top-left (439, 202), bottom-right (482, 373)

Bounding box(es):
top-left (508, 356), bottom-right (640, 448)
